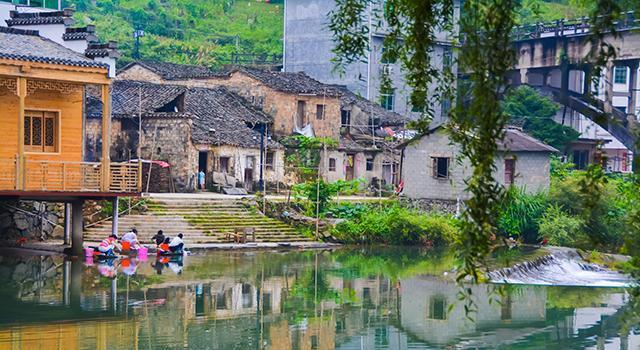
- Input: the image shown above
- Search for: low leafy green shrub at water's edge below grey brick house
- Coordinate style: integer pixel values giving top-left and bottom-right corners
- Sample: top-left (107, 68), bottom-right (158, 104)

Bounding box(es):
top-left (333, 204), bottom-right (458, 245)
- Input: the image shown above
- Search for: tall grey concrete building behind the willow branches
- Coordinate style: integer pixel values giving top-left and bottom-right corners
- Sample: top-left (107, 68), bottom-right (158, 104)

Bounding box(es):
top-left (283, 0), bottom-right (460, 121)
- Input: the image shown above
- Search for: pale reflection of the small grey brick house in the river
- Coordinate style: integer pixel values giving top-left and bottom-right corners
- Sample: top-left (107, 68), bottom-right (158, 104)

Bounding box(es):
top-left (400, 277), bottom-right (546, 344)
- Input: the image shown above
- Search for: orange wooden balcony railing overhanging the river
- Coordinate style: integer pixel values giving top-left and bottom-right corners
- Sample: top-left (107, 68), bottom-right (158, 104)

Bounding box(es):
top-left (0, 159), bottom-right (140, 193)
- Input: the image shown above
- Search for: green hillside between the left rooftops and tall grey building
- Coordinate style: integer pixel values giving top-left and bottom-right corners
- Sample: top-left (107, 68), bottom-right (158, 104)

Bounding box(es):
top-left (65, 0), bottom-right (283, 66)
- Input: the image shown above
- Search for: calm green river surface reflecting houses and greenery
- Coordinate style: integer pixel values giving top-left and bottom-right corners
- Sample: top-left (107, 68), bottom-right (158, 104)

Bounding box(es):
top-left (0, 248), bottom-right (640, 350)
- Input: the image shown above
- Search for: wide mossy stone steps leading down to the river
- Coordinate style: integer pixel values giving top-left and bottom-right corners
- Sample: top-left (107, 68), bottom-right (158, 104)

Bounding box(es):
top-left (85, 198), bottom-right (312, 244)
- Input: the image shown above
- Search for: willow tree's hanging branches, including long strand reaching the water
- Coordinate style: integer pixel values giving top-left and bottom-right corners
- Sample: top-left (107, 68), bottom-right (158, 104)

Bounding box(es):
top-left (329, 0), bottom-right (638, 298)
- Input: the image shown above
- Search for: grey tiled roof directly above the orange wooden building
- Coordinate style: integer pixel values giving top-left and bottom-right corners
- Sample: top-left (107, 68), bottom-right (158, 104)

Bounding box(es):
top-left (0, 27), bottom-right (108, 68)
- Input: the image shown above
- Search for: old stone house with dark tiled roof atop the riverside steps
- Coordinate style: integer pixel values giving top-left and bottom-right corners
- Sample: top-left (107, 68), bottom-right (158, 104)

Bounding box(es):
top-left (85, 80), bottom-right (284, 192)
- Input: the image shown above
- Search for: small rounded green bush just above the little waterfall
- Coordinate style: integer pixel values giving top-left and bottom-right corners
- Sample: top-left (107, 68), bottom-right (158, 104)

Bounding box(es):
top-left (538, 205), bottom-right (585, 247)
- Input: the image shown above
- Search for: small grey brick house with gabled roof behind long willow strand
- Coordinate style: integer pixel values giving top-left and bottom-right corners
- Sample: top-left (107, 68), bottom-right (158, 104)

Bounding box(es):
top-left (401, 126), bottom-right (558, 201)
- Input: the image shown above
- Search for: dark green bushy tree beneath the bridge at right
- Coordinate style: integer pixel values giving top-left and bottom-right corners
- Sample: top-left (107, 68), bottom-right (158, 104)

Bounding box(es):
top-left (503, 86), bottom-right (580, 151)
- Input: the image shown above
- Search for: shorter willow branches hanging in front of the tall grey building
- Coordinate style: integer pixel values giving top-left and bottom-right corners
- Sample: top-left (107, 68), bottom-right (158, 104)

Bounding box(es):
top-left (329, 0), bottom-right (455, 120)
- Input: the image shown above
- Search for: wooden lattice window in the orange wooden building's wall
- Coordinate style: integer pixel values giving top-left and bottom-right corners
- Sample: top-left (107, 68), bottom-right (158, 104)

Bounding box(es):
top-left (22, 108), bottom-right (62, 154)
